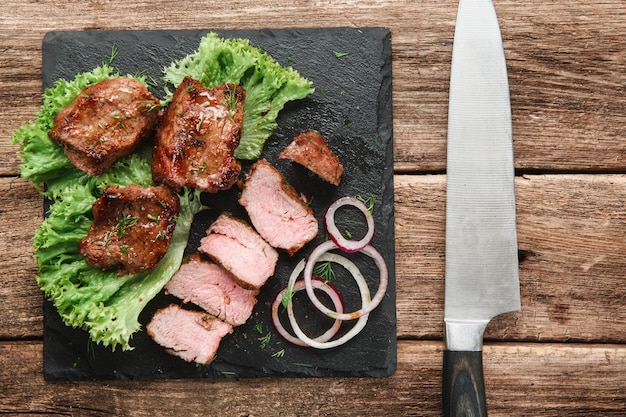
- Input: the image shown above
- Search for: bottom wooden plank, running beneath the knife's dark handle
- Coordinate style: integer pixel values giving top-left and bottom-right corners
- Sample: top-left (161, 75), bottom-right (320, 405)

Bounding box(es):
top-left (0, 341), bottom-right (626, 417)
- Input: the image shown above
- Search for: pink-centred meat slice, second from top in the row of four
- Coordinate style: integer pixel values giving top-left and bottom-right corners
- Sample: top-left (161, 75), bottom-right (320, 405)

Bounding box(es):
top-left (198, 214), bottom-right (278, 290)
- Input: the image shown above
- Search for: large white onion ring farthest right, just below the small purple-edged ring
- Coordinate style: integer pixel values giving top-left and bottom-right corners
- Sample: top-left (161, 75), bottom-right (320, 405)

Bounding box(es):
top-left (304, 240), bottom-right (389, 320)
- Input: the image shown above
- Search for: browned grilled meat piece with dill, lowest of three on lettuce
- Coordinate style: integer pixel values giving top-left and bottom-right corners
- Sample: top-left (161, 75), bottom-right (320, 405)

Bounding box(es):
top-left (78, 184), bottom-right (180, 274)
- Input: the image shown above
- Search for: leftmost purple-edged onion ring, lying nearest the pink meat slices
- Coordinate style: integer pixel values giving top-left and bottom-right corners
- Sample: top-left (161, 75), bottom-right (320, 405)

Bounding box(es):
top-left (272, 259), bottom-right (343, 347)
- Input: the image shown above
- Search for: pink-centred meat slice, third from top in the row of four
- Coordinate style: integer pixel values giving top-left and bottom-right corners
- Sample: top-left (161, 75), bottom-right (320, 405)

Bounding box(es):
top-left (165, 254), bottom-right (257, 326)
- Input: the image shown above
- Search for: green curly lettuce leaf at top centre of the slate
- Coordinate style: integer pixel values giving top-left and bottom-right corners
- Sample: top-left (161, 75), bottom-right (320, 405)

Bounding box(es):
top-left (164, 33), bottom-right (314, 160)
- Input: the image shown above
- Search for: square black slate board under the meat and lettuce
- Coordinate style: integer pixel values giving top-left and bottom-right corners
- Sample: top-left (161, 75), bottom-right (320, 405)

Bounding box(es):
top-left (42, 28), bottom-right (396, 380)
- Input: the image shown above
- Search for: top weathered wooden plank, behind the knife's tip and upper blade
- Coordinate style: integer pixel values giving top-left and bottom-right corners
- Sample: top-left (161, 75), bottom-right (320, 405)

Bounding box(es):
top-left (0, 0), bottom-right (626, 175)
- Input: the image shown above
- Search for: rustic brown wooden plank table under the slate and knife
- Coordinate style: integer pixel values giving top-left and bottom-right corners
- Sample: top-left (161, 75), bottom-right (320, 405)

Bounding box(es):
top-left (0, 0), bottom-right (626, 417)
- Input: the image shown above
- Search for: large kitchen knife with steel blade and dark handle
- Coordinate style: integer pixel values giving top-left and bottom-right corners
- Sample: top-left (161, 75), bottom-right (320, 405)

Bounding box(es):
top-left (443, 0), bottom-right (520, 416)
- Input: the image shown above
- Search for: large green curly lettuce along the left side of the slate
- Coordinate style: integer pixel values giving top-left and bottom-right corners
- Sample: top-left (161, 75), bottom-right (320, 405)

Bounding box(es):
top-left (12, 64), bottom-right (204, 350)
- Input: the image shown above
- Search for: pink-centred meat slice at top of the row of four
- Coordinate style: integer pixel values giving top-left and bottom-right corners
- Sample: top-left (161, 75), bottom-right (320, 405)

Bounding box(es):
top-left (239, 159), bottom-right (318, 255)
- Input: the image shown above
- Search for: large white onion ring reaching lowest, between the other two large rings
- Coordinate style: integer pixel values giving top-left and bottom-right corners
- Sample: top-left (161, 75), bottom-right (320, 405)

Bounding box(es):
top-left (287, 254), bottom-right (370, 349)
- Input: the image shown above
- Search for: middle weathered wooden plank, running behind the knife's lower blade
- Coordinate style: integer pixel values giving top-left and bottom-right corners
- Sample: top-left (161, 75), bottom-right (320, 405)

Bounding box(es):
top-left (6, 175), bottom-right (626, 343)
